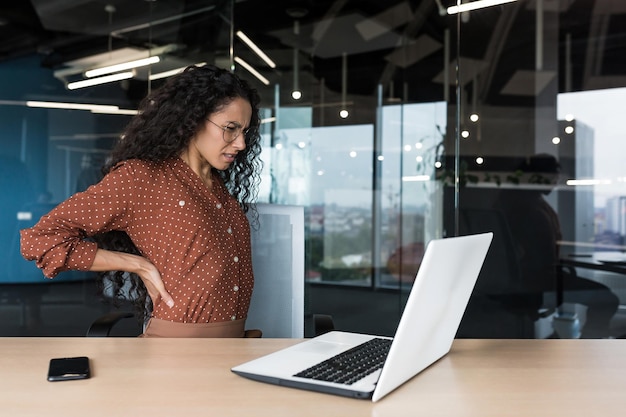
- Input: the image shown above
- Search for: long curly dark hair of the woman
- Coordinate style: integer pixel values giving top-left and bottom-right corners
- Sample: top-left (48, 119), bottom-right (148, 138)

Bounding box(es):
top-left (94, 65), bottom-right (262, 321)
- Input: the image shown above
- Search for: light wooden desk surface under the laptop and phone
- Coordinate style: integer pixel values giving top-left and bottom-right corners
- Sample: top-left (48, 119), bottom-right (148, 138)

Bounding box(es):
top-left (0, 338), bottom-right (626, 417)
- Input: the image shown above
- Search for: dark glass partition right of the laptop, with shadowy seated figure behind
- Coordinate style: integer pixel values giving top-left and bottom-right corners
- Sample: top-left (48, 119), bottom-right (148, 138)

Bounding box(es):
top-left (444, 0), bottom-right (626, 338)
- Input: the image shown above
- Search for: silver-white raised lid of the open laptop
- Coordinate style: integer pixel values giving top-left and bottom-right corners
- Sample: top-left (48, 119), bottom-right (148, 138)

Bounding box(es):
top-left (372, 233), bottom-right (493, 401)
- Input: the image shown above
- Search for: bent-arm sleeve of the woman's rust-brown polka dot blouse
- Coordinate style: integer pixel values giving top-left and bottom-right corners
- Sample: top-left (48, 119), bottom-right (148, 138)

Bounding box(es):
top-left (20, 163), bottom-right (134, 278)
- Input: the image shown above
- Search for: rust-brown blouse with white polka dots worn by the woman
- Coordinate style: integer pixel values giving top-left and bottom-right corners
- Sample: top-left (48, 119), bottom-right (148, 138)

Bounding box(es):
top-left (21, 158), bottom-right (254, 323)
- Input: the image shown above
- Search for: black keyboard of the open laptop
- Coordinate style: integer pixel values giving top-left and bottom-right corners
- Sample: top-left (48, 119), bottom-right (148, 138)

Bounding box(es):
top-left (294, 338), bottom-right (392, 385)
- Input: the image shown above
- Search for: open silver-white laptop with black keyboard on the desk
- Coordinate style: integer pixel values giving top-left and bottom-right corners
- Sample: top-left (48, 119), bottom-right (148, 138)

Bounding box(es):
top-left (231, 232), bottom-right (493, 402)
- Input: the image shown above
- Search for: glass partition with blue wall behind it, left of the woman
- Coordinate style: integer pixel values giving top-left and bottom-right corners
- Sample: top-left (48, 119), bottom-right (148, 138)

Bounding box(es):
top-left (0, 1), bottom-right (233, 336)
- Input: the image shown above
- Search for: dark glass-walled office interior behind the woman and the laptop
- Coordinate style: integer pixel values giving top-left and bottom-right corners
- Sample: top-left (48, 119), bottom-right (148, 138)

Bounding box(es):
top-left (0, 0), bottom-right (626, 338)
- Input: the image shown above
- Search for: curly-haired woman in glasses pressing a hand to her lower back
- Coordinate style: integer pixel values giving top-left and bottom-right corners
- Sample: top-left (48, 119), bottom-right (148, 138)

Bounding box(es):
top-left (21, 66), bottom-right (261, 337)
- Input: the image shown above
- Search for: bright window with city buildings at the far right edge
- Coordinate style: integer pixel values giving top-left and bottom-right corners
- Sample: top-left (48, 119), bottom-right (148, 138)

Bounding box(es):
top-left (558, 88), bottom-right (626, 250)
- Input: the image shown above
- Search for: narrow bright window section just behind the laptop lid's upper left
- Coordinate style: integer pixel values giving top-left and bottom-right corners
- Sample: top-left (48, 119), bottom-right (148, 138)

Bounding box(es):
top-left (377, 102), bottom-right (446, 287)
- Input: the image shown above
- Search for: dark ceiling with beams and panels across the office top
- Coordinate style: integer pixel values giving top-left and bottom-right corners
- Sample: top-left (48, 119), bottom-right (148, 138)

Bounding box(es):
top-left (0, 0), bottom-right (626, 105)
